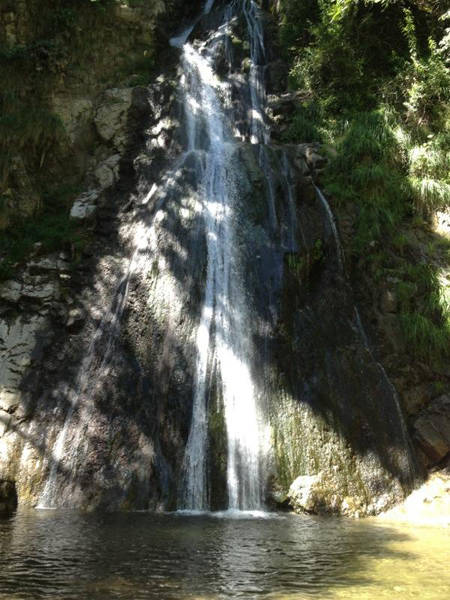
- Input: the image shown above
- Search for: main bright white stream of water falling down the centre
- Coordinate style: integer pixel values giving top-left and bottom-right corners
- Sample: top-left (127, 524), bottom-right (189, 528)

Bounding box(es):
top-left (179, 0), bottom-right (269, 510)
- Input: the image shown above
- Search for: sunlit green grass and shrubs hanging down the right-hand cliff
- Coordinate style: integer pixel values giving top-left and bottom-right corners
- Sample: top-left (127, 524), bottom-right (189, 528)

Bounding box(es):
top-left (274, 0), bottom-right (450, 365)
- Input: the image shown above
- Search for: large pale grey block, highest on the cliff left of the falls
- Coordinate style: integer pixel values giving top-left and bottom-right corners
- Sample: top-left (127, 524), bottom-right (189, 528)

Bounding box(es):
top-left (94, 88), bottom-right (133, 152)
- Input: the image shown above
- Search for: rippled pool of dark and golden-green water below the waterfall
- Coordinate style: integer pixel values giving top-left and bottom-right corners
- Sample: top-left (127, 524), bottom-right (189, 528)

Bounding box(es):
top-left (0, 511), bottom-right (450, 600)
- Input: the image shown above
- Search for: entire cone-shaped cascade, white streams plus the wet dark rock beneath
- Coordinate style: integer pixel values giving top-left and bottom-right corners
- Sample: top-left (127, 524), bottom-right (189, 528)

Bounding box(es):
top-left (32, 0), bottom-right (418, 514)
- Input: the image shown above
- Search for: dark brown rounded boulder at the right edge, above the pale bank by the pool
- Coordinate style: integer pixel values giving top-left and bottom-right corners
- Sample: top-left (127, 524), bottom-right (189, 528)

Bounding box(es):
top-left (414, 395), bottom-right (450, 466)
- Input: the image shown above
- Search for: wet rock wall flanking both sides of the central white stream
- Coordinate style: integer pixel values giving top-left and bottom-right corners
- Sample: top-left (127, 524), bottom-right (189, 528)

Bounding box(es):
top-left (0, 3), bottom-right (415, 515)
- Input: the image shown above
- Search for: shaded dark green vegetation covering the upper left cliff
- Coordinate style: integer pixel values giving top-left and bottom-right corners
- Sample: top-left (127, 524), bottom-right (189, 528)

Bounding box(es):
top-left (0, 0), bottom-right (160, 279)
